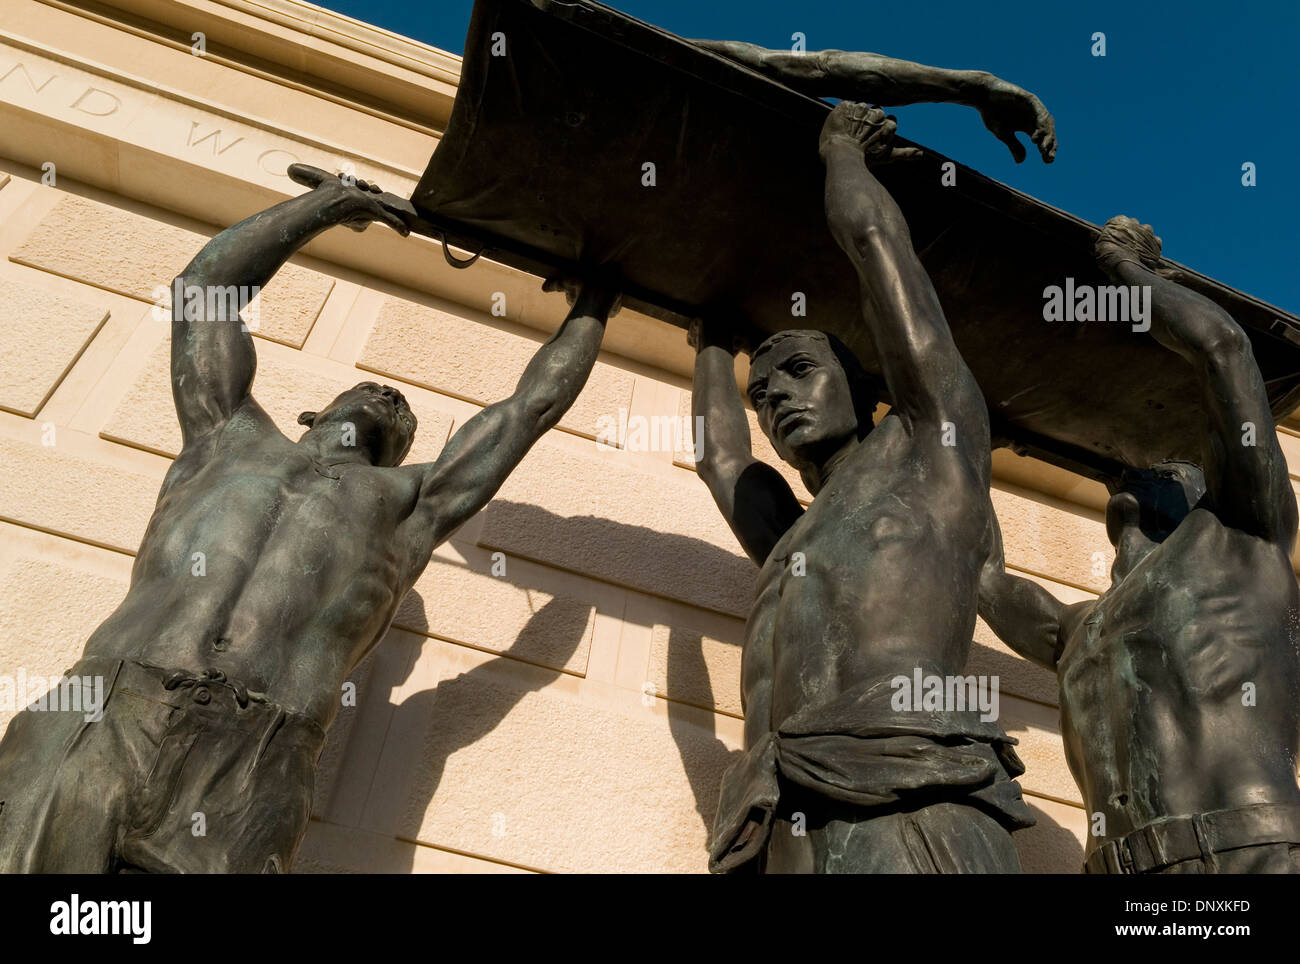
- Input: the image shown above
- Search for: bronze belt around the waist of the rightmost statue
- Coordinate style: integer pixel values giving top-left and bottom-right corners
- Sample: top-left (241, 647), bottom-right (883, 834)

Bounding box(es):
top-left (1083, 803), bottom-right (1300, 874)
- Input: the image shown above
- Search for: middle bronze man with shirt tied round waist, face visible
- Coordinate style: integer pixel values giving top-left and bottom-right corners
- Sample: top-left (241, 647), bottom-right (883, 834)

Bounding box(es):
top-left (694, 101), bottom-right (1034, 873)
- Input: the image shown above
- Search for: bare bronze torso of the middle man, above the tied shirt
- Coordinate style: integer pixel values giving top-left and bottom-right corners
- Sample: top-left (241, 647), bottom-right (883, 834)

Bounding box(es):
top-left (742, 416), bottom-right (992, 744)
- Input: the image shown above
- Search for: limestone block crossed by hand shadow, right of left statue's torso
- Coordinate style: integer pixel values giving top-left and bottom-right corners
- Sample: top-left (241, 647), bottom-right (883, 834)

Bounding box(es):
top-left (394, 556), bottom-right (595, 676)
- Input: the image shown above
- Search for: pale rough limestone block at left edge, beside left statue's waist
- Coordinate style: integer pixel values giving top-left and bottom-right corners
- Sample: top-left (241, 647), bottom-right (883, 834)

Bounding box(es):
top-left (0, 557), bottom-right (129, 731)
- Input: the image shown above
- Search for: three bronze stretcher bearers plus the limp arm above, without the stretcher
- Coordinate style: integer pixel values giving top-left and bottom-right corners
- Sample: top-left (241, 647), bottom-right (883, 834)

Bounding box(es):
top-left (0, 43), bottom-right (1300, 873)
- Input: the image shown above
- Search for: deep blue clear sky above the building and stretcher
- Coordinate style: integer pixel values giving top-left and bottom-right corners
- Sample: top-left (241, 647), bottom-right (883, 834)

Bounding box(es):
top-left (322, 0), bottom-right (1300, 313)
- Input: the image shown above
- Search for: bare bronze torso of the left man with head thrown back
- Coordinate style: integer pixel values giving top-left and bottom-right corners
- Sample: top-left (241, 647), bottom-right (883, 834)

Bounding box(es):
top-left (86, 403), bottom-right (432, 726)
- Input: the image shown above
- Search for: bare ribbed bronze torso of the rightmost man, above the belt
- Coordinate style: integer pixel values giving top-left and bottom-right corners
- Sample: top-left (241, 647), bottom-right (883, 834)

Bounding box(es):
top-left (1057, 509), bottom-right (1300, 837)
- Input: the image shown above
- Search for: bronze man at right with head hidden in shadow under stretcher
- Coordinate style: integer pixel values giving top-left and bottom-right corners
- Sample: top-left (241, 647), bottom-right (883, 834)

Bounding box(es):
top-left (980, 217), bottom-right (1300, 873)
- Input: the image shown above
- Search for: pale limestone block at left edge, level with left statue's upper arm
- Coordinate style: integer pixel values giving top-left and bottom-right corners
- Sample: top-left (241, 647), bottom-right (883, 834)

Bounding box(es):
top-left (0, 281), bottom-right (108, 416)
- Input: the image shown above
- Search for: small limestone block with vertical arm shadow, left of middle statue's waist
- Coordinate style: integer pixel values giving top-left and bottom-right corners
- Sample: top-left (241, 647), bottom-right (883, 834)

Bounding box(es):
top-left (650, 624), bottom-right (744, 717)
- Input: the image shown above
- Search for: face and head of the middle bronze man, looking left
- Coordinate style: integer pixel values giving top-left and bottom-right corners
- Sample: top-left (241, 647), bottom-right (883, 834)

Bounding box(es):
top-left (746, 331), bottom-right (858, 470)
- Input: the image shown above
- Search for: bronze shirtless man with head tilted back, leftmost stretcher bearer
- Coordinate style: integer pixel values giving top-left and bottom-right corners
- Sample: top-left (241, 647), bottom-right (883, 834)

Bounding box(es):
top-left (0, 169), bottom-right (616, 873)
